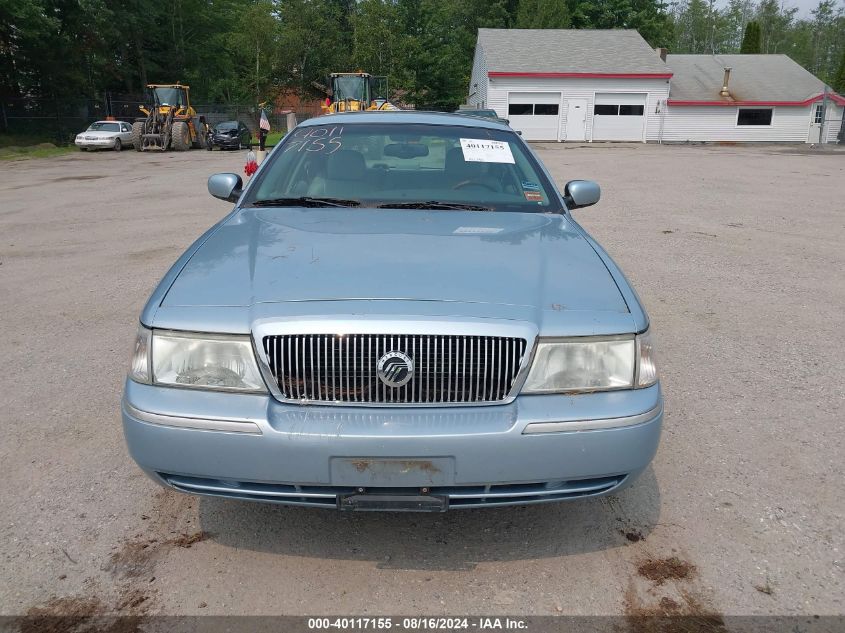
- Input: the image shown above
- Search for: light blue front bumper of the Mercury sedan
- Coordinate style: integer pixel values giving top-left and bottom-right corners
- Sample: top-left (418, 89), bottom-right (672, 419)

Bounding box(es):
top-left (122, 381), bottom-right (663, 510)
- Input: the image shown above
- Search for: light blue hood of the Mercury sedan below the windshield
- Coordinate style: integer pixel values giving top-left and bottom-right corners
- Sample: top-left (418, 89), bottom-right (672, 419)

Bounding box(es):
top-left (162, 208), bottom-right (628, 312)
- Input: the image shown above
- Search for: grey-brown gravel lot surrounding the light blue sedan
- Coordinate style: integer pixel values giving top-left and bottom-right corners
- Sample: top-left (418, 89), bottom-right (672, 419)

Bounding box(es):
top-left (0, 139), bottom-right (845, 615)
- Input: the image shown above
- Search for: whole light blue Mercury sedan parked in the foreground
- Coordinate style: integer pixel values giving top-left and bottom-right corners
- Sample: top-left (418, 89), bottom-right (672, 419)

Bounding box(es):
top-left (122, 112), bottom-right (663, 512)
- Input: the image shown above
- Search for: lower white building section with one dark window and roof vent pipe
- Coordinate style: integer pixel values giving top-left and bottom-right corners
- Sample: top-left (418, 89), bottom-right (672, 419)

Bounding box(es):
top-left (660, 55), bottom-right (845, 143)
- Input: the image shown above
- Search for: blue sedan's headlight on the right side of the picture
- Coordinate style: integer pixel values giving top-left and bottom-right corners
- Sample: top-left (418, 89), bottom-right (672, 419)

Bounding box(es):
top-left (522, 332), bottom-right (657, 393)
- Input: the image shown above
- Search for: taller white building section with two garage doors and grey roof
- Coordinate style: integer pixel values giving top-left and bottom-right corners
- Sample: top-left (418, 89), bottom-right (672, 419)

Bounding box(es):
top-left (467, 29), bottom-right (672, 142)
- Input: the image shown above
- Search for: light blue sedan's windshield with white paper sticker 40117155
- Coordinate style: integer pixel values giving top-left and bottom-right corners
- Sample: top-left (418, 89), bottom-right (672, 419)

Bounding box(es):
top-left (243, 122), bottom-right (561, 213)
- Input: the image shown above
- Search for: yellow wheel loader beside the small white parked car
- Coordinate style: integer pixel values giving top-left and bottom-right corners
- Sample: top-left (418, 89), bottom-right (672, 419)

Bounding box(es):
top-left (132, 84), bottom-right (207, 152)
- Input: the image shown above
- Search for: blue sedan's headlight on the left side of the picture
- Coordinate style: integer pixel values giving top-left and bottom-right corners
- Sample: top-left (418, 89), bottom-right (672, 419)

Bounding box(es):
top-left (130, 330), bottom-right (266, 392)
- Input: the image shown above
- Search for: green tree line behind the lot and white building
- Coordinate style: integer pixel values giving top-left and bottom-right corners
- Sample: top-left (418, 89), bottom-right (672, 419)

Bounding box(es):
top-left (0, 0), bottom-right (845, 109)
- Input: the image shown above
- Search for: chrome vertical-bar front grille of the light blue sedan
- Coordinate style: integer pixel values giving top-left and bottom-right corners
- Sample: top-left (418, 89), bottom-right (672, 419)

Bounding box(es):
top-left (263, 334), bottom-right (527, 404)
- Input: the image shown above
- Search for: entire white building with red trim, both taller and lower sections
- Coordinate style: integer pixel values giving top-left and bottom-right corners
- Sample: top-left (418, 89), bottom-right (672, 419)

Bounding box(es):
top-left (467, 29), bottom-right (845, 143)
